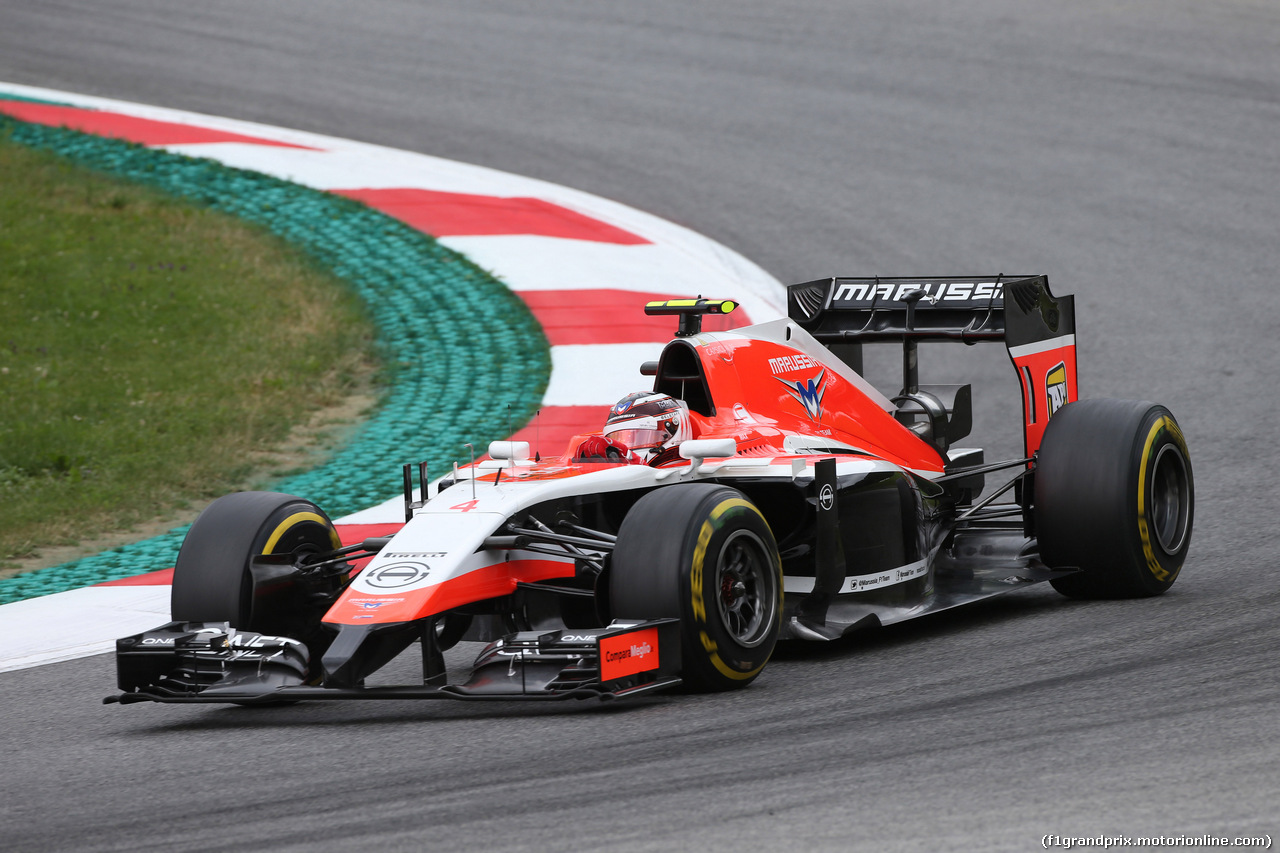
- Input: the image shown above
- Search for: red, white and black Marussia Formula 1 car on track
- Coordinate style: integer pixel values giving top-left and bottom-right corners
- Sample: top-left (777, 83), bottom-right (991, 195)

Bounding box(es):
top-left (108, 275), bottom-right (1194, 703)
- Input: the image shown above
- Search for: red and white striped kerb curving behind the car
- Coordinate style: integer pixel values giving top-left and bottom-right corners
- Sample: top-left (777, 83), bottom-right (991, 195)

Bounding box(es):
top-left (0, 82), bottom-right (785, 672)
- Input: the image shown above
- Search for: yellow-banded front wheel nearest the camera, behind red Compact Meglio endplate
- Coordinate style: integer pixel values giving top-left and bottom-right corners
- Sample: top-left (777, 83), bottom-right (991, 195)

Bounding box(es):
top-left (608, 483), bottom-right (782, 692)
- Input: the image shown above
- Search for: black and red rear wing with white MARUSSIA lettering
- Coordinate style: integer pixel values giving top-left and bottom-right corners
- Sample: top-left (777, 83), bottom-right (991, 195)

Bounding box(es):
top-left (787, 275), bottom-right (1078, 456)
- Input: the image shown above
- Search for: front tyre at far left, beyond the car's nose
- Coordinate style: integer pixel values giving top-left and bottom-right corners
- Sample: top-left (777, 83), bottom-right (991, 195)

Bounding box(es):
top-left (170, 492), bottom-right (342, 630)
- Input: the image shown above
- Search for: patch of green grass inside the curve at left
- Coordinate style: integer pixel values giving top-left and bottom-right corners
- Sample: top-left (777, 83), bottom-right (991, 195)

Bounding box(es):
top-left (0, 138), bottom-right (375, 566)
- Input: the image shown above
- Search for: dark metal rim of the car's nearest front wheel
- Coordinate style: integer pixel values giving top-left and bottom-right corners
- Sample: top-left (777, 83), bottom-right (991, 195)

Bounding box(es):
top-left (716, 530), bottom-right (777, 648)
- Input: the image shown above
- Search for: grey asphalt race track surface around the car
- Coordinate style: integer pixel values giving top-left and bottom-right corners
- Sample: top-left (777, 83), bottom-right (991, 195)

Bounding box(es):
top-left (0, 0), bottom-right (1280, 850)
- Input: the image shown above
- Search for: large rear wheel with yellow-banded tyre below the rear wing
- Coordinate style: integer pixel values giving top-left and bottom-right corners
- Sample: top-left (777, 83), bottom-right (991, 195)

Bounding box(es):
top-left (1036, 400), bottom-right (1196, 598)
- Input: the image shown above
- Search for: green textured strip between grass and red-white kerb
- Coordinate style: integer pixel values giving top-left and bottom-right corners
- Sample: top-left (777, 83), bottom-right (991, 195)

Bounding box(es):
top-left (0, 117), bottom-right (550, 605)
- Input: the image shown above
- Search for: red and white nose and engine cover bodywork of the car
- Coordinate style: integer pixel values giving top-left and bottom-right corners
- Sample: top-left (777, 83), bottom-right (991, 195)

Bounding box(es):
top-left (324, 313), bottom-right (943, 625)
